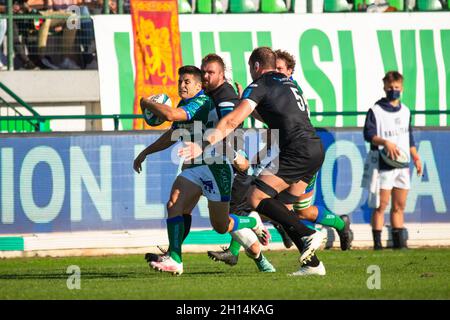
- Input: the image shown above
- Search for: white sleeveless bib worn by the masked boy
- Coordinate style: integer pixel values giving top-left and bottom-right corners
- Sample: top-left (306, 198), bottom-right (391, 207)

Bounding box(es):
top-left (372, 104), bottom-right (411, 161)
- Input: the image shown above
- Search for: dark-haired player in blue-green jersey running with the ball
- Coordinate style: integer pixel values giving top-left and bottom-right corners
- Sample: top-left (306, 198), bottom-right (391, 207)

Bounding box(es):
top-left (133, 66), bottom-right (267, 275)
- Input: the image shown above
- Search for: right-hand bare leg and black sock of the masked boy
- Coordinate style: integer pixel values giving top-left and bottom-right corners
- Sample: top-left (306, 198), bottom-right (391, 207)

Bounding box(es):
top-left (391, 188), bottom-right (408, 249)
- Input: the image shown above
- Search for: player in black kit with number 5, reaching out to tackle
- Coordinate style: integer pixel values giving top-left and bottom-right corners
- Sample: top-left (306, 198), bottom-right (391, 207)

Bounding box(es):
top-left (179, 47), bottom-right (325, 265)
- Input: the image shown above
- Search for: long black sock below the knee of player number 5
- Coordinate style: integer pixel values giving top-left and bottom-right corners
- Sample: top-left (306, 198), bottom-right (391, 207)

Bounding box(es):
top-left (256, 198), bottom-right (315, 238)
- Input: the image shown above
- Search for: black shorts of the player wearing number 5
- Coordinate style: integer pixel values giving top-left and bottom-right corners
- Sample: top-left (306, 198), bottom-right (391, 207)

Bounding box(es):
top-left (268, 137), bottom-right (325, 184)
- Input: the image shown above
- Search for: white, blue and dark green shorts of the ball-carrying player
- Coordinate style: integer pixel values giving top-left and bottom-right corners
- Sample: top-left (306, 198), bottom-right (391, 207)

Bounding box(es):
top-left (180, 164), bottom-right (234, 202)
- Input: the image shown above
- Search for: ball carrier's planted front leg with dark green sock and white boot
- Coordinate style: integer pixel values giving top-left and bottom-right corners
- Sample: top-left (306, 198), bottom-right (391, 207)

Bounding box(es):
top-left (150, 175), bottom-right (201, 274)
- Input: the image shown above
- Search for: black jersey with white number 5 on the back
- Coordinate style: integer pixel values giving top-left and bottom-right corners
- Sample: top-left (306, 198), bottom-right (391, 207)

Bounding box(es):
top-left (242, 71), bottom-right (318, 149)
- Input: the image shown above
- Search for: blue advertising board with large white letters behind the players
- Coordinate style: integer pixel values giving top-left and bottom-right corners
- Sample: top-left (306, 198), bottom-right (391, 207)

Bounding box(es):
top-left (0, 128), bottom-right (450, 255)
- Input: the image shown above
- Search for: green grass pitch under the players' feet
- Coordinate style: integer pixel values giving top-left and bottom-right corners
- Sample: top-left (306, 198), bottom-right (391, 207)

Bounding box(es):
top-left (0, 249), bottom-right (450, 300)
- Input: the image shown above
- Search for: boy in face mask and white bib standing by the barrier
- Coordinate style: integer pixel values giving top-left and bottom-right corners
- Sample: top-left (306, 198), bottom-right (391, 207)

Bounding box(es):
top-left (363, 71), bottom-right (422, 250)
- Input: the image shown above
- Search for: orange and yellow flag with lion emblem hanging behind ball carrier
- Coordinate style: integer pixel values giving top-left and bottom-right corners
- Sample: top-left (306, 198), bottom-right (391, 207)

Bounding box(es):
top-left (130, 0), bottom-right (182, 129)
